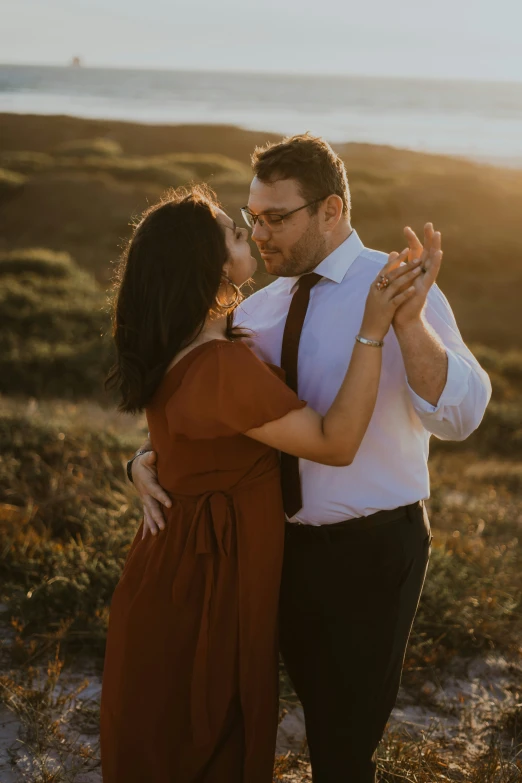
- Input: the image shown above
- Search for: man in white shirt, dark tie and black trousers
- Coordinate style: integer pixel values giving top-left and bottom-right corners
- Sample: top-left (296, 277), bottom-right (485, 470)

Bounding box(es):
top-left (131, 135), bottom-right (491, 783)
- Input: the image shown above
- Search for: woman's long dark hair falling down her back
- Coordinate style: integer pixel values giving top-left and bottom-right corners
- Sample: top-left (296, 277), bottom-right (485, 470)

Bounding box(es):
top-left (105, 186), bottom-right (244, 413)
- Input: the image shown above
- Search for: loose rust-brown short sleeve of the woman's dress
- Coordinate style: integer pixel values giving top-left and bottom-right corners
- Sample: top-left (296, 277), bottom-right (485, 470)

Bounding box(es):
top-left (165, 340), bottom-right (306, 440)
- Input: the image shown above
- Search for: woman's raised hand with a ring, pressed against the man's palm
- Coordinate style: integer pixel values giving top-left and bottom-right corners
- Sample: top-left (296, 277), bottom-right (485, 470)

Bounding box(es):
top-left (361, 248), bottom-right (422, 340)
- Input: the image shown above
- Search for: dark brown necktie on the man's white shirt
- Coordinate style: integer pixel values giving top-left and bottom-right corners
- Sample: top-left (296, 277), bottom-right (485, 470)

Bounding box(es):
top-left (281, 272), bottom-right (321, 517)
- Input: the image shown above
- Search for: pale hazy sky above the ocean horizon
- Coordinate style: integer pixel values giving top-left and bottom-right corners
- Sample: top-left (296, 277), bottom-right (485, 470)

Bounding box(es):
top-left (4, 0), bottom-right (522, 81)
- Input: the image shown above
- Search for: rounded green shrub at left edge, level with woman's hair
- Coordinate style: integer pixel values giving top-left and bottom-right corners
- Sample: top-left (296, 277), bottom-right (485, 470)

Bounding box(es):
top-left (0, 249), bottom-right (112, 398)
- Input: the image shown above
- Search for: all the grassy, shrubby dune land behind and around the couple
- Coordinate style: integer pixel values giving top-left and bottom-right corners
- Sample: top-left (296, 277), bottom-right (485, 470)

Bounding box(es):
top-left (0, 115), bottom-right (522, 783)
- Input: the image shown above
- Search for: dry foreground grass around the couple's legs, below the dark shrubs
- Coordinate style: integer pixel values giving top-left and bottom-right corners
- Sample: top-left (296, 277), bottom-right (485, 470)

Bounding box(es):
top-left (0, 390), bottom-right (522, 783)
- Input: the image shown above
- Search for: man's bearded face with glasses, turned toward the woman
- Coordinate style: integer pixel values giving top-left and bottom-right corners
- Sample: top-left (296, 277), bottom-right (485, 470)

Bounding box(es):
top-left (248, 177), bottom-right (327, 277)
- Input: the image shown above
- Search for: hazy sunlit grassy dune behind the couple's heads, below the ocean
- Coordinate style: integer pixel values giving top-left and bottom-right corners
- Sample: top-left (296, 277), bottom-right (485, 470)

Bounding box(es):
top-left (0, 114), bottom-right (522, 348)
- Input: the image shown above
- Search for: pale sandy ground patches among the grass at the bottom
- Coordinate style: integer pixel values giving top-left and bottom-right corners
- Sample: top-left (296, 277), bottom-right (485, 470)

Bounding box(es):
top-left (0, 588), bottom-right (522, 783)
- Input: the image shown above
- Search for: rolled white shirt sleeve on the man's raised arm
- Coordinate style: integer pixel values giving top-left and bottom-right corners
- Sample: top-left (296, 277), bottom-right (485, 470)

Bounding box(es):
top-left (408, 286), bottom-right (491, 440)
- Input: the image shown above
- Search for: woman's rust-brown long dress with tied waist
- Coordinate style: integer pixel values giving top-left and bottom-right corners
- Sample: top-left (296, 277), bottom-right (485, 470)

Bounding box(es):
top-left (101, 340), bottom-right (305, 783)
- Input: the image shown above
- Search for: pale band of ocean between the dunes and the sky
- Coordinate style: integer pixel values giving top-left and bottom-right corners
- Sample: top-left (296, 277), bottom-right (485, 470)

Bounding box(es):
top-left (0, 65), bottom-right (522, 168)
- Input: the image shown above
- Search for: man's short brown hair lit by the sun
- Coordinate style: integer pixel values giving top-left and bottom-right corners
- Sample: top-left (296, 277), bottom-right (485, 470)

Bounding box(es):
top-left (252, 133), bottom-right (350, 217)
